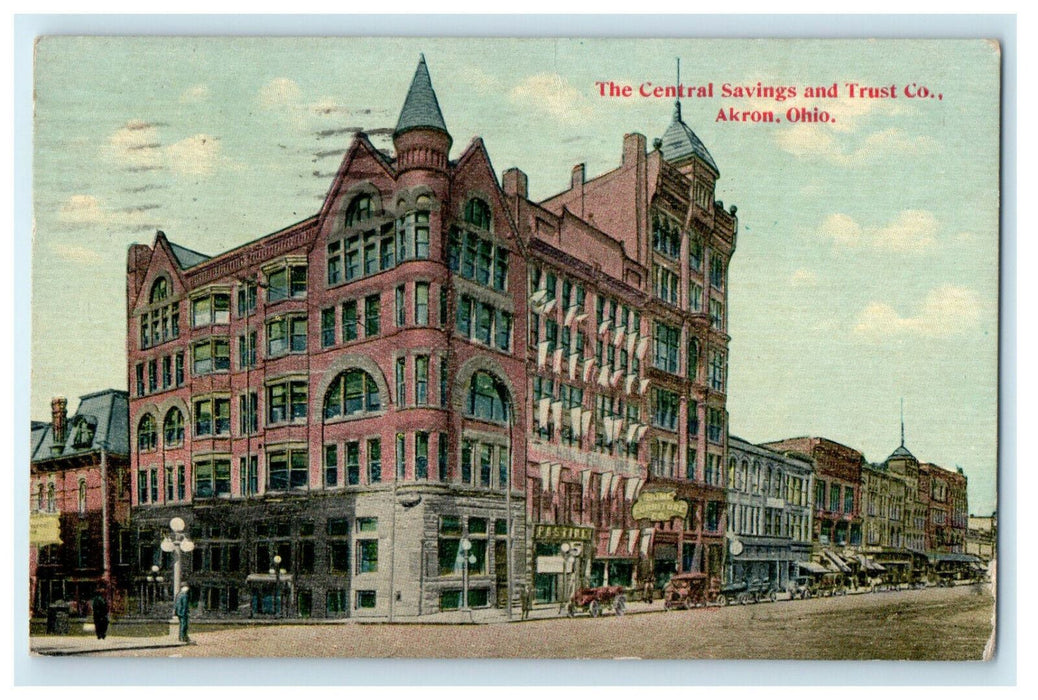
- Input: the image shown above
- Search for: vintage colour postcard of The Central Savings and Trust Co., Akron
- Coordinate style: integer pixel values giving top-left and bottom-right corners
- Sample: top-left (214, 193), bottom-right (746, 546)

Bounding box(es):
top-left (22, 36), bottom-right (1002, 661)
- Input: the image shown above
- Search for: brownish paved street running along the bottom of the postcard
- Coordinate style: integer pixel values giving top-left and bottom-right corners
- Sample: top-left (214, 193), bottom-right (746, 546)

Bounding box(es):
top-left (69, 586), bottom-right (993, 659)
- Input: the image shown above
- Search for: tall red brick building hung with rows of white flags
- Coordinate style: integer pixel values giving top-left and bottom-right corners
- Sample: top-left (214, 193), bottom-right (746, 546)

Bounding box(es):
top-left (504, 96), bottom-right (737, 600)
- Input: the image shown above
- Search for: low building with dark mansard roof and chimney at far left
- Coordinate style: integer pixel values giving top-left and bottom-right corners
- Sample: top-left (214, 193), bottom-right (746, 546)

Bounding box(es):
top-left (29, 389), bottom-right (132, 615)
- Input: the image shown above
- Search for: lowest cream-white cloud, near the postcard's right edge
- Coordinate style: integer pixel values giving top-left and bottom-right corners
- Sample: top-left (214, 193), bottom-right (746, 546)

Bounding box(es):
top-left (854, 285), bottom-right (981, 341)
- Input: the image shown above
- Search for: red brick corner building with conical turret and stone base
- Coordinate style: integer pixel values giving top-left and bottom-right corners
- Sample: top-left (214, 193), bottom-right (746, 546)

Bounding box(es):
top-left (127, 58), bottom-right (526, 617)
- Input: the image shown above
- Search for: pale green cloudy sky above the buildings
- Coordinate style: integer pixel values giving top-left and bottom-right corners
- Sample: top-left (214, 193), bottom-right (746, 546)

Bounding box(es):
top-left (30, 37), bottom-right (999, 513)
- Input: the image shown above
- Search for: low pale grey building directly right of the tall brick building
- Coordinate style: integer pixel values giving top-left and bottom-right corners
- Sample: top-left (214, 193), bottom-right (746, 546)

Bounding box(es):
top-left (726, 435), bottom-right (814, 590)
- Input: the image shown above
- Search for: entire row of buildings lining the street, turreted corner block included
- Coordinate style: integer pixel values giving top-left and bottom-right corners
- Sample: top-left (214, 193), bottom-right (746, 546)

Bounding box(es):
top-left (32, 59), bottom-right (988, 618)
